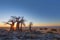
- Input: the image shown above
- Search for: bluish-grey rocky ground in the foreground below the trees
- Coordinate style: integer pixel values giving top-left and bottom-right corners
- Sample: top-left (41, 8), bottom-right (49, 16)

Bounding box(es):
top-left (0, 29), bottom-right (60, 40)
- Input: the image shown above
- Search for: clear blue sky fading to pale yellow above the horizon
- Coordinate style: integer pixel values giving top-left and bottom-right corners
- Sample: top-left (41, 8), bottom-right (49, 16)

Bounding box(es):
top-left (0, 0), bottom-right (60, 26)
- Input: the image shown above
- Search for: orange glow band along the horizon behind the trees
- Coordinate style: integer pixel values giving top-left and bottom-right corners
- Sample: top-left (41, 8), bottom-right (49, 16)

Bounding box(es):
top-left (0, 23), bottom-right (60, 27)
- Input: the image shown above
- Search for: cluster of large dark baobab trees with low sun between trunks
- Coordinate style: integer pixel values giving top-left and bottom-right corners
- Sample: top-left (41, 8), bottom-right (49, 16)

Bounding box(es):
top-left (5, 16), bottom-right (25, 31)
